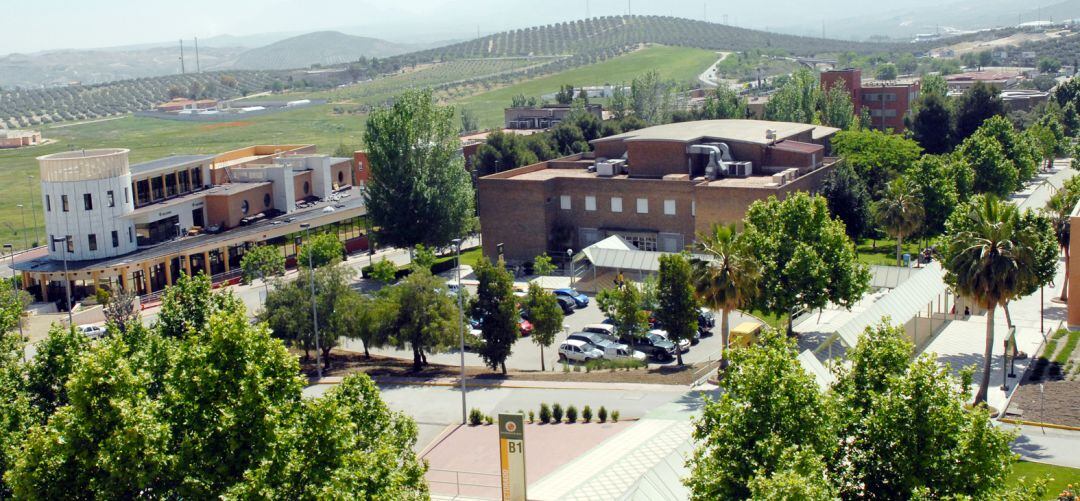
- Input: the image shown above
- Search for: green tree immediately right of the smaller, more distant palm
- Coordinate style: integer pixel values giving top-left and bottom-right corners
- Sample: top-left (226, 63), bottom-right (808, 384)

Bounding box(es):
top-left (902, 155), bottom-right (959, 235)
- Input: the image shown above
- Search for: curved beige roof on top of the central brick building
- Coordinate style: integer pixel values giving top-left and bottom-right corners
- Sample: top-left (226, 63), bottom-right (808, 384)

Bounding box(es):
top-left (593, 120), bottom-right (839, 145)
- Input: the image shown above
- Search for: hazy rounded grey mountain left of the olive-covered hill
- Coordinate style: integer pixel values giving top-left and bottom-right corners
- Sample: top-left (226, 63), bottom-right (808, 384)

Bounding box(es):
top-left (230, 31), bottom-right (431, 69)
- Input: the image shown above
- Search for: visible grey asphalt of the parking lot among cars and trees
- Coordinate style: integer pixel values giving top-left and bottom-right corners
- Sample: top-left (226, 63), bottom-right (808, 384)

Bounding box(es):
top-left (342, 289), bottom-right (751, 370)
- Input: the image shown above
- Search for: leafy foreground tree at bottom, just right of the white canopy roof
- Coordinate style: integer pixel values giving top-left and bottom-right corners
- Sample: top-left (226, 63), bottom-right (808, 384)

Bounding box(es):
top-left (684, 329), bottom-right (837, 500)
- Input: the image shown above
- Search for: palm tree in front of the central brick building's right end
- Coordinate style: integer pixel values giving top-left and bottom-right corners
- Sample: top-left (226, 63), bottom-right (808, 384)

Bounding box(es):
top-left (690, 225), bottom-right (761, 370)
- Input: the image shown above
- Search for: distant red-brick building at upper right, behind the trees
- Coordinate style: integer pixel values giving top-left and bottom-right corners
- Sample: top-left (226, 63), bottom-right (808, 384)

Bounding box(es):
top-left (821, 68), bottom-right (919, 134)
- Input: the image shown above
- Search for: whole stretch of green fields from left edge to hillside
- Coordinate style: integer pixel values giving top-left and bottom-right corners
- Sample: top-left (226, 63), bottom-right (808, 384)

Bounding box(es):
top-left (0, 46), bottom-right (717, 248)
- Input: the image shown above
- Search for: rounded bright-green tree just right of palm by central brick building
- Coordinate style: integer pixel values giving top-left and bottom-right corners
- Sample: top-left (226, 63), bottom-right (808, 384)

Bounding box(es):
top-left (743, 192), bottom-right (869, 330)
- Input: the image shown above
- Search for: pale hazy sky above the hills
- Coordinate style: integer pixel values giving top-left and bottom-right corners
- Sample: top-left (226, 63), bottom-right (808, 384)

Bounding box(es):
top-left (0, 0), bottom-right (907, 54)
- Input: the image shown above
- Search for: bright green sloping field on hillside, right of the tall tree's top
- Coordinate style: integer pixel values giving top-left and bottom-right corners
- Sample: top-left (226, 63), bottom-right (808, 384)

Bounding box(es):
top-left (454, 45), bottom-right (719, 127)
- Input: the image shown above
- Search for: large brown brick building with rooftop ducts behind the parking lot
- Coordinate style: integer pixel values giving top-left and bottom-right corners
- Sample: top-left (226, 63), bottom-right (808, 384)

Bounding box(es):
top-left (477, 120), bottom-right (837, 262)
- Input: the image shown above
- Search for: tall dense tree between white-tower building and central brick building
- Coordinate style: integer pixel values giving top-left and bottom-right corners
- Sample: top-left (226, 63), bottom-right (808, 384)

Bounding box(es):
top-left (364, 91), bottom-right (474, 247)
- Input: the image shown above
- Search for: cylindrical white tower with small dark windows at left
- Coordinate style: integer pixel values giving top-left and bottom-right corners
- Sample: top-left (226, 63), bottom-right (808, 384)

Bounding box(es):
top-left (38, 148), bottom-right (138, 260)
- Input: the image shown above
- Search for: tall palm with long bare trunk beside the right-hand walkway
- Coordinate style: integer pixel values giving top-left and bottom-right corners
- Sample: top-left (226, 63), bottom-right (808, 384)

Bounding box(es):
top-left (944, 195), bottom-right (1034, 404)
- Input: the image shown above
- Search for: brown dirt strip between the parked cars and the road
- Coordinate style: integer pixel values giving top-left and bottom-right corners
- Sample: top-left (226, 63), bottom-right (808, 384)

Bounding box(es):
top-left (298, 350), bottom-right (716, 385)
